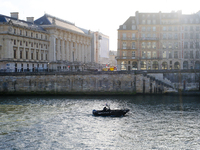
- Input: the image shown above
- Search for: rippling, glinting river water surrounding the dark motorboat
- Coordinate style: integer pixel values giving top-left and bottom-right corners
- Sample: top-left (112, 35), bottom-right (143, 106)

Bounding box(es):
top-left (0, 95), bottom-right (200, 150)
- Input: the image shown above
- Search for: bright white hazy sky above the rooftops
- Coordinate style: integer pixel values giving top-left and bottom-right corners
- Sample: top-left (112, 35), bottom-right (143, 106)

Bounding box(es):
top-left (0, 0), bottom-right (200, 50)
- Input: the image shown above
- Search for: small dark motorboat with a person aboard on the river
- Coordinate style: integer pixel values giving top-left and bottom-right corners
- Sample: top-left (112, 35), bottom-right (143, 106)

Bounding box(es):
top-left (92, 107), bottom-right (129, 117)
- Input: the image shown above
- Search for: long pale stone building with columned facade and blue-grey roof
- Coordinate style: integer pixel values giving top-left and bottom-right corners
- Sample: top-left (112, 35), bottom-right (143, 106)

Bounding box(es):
top-left (0, 12), bottom-right (109, 72)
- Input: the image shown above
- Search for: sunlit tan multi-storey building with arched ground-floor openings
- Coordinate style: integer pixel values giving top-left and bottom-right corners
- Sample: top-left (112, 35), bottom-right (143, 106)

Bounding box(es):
top-left (116, 11), bottom-right (200, 70)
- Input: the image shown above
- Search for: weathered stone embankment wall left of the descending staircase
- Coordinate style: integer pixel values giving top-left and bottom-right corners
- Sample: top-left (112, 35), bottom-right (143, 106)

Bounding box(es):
top-left (0, 72), bottom-right (167, 95)
